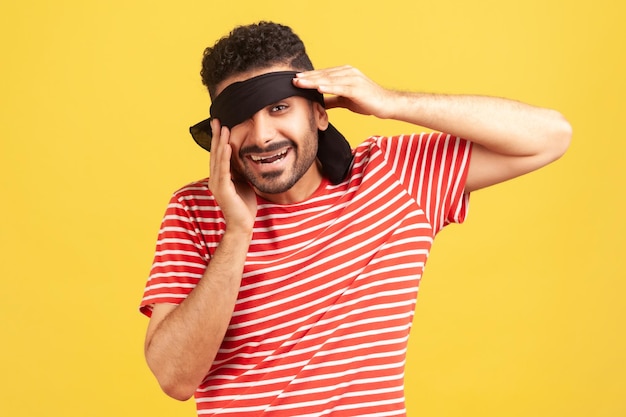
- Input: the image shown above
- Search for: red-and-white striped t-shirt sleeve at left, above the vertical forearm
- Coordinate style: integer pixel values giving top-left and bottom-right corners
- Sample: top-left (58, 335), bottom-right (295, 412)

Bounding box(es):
top-left (140, 187), bottom-right (209, 316)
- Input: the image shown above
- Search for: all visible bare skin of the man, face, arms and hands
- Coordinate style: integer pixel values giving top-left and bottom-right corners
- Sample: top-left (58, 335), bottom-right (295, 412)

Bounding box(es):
top-left (145, 65), bottom-right (571, 400)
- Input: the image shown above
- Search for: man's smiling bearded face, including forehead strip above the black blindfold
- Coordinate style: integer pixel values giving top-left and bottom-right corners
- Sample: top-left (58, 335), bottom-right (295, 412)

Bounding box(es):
top-left (213, 66), bottom-right (328, 203)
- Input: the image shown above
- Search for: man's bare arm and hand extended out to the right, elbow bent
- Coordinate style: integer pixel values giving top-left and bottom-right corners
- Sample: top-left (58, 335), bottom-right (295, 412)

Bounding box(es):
top-left (294, 66), bottom-right (572, 191)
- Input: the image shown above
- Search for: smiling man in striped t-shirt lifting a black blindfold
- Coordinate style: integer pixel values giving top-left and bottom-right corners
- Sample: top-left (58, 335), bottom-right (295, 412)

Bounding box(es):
top-left (141, 22), bottom-right (571, 416)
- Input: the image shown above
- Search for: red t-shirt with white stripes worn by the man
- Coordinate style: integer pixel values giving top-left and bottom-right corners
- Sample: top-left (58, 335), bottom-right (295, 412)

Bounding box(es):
top-left (141, 133), bottom-right (471, 417)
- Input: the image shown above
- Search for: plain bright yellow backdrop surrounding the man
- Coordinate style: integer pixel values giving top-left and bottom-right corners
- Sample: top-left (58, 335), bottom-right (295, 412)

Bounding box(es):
top-left (0, 0), bottom-right (626, 417)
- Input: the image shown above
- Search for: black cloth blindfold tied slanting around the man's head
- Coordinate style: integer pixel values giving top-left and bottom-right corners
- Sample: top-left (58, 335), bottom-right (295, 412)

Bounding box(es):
top-left (189, 71), bottom-right (352, 184)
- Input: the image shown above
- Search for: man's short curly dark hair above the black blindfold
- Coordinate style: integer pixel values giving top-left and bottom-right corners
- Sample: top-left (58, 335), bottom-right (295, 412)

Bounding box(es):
top-left (200, 21), bottom-right (313, 98)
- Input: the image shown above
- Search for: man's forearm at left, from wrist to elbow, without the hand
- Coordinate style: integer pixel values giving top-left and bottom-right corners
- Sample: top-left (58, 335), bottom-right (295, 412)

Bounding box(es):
top-left (145, 232), bottom-right (251, 400)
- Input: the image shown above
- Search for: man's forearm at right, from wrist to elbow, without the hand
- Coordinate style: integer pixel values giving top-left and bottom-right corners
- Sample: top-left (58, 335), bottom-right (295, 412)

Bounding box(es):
top-left (388, 92), bottom-right (571, 156)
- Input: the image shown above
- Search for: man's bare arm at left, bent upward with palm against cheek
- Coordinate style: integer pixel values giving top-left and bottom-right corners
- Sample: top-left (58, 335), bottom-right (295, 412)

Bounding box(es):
top-left (145, 122), bottom-right (256, 400)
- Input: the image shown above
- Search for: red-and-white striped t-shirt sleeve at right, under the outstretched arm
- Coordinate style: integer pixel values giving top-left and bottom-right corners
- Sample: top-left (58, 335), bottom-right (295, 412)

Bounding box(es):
top-left (376, 132), bottom-right (471, 234)
